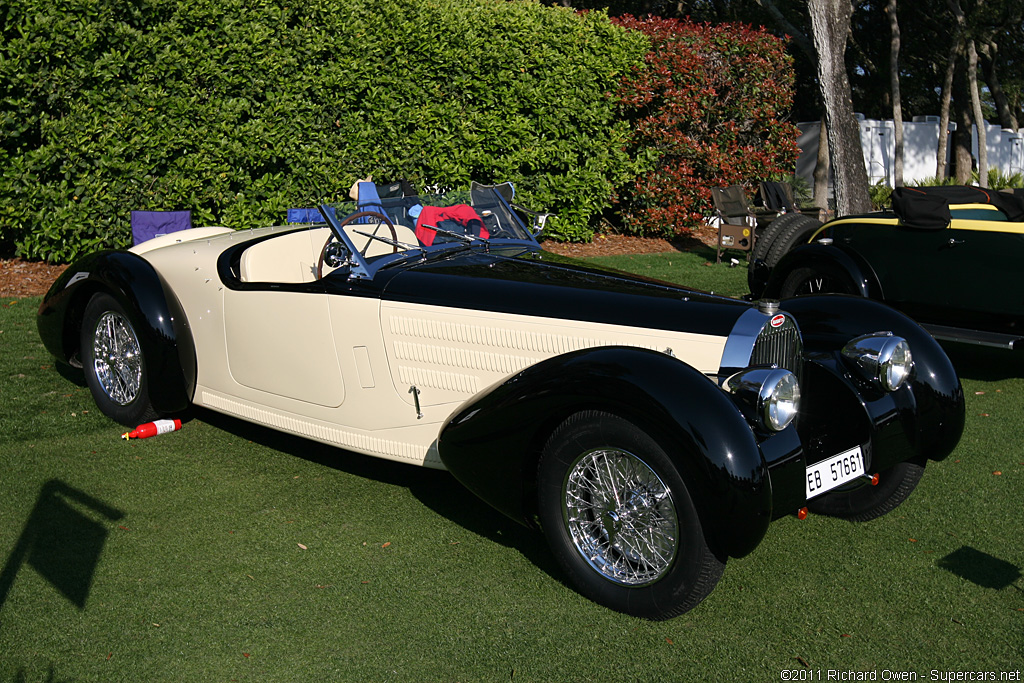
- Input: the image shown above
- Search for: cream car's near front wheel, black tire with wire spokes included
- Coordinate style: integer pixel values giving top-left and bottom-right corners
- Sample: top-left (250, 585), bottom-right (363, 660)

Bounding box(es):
top-left (539, 412), bottom-right (725, 620)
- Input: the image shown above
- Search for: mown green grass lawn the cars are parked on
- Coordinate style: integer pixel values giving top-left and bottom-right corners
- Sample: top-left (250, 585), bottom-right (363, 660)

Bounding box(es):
top-left (0, 253), bottom-right (1024, 683)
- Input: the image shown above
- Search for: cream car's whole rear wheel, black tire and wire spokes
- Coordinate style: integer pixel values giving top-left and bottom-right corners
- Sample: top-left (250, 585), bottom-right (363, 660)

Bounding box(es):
top-left (80, 293), bottom-right (159, 427)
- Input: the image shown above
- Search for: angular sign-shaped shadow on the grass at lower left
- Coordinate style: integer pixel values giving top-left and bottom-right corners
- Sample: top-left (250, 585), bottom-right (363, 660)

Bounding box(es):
top-left (0, 479), bottom-right (124, 626)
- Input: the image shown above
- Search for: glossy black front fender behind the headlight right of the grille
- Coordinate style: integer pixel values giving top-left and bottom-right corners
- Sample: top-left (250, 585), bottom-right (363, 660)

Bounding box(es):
top-left (780, 295), bottom-right (965, 471)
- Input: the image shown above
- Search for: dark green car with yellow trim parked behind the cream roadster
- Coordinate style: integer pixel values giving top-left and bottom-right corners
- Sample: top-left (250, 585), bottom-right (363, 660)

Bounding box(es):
top-left (748, 186), bottom-right (1024, 349)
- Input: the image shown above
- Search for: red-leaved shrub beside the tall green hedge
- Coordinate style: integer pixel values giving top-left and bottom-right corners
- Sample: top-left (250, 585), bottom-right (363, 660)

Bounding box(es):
top-left (616, 15), bottom-right (799, 237)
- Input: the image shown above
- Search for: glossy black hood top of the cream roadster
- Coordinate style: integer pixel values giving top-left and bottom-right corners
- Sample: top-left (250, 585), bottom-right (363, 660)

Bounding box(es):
top-left (383, 250), bottom-right (751, 336)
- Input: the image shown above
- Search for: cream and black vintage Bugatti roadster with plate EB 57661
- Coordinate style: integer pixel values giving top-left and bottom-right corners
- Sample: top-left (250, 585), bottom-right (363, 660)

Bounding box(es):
top-left (38, 187), bottom-right (964, 618)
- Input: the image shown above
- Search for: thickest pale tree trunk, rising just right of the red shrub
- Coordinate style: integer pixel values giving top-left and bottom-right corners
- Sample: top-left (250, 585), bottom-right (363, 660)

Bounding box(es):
top-left (808, 0), bottom-right (871, 216)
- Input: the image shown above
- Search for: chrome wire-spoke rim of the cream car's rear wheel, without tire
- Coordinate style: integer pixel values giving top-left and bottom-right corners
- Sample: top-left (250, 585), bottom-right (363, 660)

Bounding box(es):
top-left (92, 311), bottom-right (142, 405)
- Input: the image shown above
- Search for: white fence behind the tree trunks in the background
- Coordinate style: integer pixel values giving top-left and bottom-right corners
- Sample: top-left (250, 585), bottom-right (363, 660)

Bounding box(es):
top-left (797, 116), bottom-right (1024, 187)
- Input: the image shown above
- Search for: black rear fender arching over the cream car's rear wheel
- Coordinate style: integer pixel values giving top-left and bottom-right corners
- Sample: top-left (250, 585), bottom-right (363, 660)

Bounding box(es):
top-left (37, 251), bottom-right (196, 414)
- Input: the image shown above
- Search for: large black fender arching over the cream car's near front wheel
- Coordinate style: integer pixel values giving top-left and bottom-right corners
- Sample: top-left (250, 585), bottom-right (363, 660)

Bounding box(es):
top-left (438, 346), bottom-right (772, 556)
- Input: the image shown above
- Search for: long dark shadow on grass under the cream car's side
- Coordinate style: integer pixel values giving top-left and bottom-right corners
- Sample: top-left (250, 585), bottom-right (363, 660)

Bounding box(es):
top-left (193, 408), bottom-right (568, 586)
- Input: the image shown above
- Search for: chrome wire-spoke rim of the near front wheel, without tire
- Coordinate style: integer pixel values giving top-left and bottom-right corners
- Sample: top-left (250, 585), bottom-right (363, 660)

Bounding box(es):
top-left (562, 449), bottom-right (679, 586)
